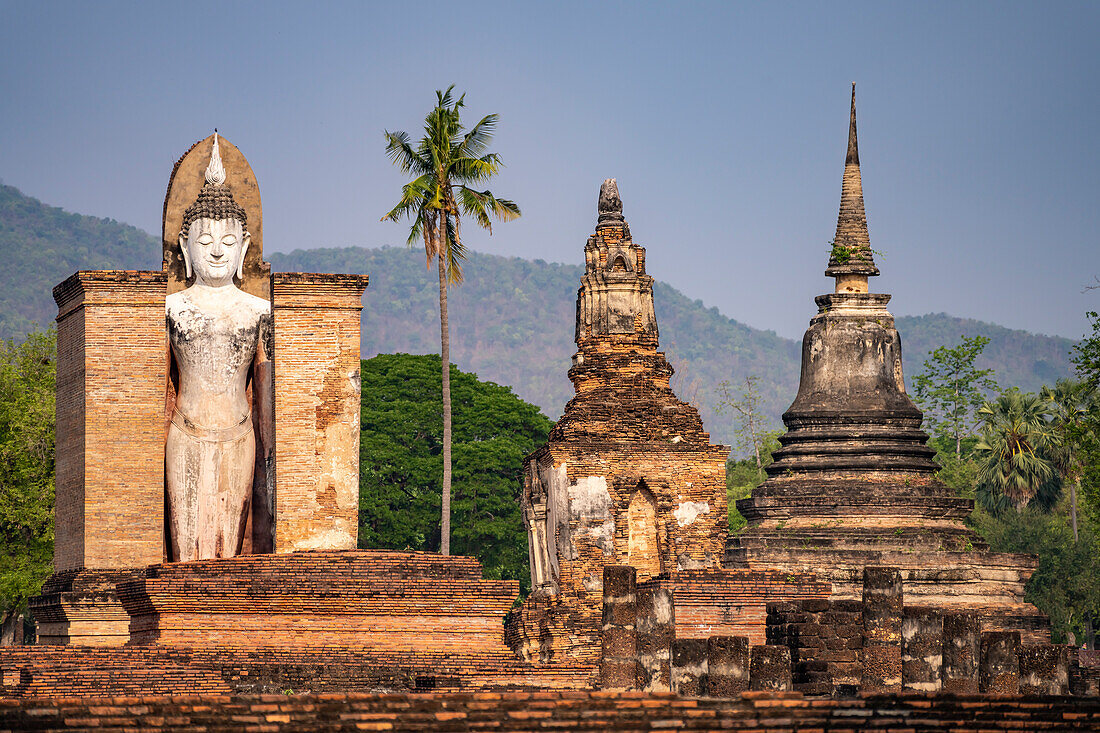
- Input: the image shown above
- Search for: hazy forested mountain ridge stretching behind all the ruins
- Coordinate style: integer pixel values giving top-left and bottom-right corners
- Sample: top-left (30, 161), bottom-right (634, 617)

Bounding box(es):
top-left (0, 185), bottom-right (1073, 444)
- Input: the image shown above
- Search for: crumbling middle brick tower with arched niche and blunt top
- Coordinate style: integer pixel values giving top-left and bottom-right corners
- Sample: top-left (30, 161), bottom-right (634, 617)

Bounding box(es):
top-left (514, 178), bottom-right (728, 658)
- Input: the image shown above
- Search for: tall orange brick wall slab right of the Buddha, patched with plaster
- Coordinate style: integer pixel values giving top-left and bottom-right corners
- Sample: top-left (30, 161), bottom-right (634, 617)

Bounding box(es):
top-left (273, 273), bottom-right (367, 553)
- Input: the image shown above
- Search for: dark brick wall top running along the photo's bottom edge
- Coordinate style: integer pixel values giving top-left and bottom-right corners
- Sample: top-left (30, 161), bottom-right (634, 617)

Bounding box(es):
top-left (0, 692), bottom-right (1100, 733)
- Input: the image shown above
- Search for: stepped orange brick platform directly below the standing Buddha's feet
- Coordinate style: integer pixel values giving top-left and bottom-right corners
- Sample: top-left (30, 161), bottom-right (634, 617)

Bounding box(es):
top-left (119, 550), bottom-right (519, 655)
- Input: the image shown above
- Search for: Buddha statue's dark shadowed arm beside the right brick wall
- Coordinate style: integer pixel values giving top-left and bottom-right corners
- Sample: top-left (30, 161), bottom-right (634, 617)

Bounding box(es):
top-left (252, 314), bottom-right (275, 553)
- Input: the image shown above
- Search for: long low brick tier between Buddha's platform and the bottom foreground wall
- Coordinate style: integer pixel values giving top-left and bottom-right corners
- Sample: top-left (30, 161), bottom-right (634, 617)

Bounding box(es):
top-left (0, 645), bottom-right (594, 695)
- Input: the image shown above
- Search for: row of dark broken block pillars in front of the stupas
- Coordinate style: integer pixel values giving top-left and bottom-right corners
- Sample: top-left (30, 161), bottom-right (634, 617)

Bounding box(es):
top-left (600, 566), bottom-right (1095, 697)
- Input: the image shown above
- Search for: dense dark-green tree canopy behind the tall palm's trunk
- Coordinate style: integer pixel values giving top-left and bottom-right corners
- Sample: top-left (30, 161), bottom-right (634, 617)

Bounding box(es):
top-left (359, 353), bottom-right (550, 590)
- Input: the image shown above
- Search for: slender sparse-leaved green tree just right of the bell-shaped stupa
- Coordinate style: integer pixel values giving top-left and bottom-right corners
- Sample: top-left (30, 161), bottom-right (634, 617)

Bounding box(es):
top-left (913, 336), bottom-right (998, 457)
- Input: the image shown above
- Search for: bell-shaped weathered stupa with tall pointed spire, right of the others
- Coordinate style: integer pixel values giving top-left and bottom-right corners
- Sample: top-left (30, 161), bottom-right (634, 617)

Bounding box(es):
top-left (724, 86), bottom-right (1047, 638)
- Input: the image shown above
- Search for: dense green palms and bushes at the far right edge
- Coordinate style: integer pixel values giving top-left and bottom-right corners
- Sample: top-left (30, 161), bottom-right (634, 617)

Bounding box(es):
top-left (926, 333), bottom-right (1100, 643)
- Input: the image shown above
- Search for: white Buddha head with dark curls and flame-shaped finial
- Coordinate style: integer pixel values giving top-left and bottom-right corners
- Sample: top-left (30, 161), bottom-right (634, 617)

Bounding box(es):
top-left (179, 131), bottom-right (251, 287)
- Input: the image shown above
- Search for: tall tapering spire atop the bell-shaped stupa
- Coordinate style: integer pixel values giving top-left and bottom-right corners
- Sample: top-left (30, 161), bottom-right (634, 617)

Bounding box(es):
top-left (825, 81), bottom-right (879, 279)
